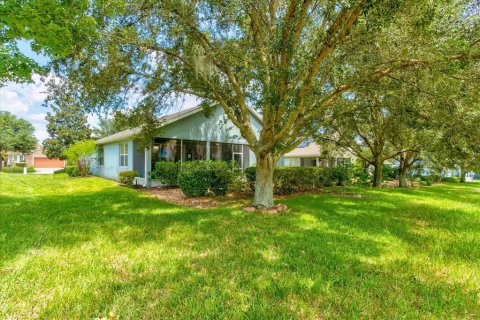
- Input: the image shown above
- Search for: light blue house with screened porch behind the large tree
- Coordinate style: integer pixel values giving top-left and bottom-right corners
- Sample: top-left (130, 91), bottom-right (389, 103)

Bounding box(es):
top-left (92, 106), bottom-right (261, 186)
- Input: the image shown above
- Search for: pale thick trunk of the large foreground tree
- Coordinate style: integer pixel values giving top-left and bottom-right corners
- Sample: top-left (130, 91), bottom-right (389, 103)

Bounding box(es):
top-left (253, 154), bottom-right (275, 208)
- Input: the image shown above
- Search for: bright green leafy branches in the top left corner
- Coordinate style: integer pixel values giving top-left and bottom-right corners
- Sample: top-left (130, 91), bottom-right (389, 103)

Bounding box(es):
top-left (0, 0), bottom-right (95, 86)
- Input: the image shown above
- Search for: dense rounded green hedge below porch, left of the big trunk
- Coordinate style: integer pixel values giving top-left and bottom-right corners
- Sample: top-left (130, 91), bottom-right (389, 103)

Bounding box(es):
top-left (178, 160), bottom-right (233, 197)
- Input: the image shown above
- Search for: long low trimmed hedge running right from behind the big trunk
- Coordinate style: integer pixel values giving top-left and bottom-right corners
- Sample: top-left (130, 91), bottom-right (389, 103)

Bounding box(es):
top-left (245, 166), bottom-right (351, 194)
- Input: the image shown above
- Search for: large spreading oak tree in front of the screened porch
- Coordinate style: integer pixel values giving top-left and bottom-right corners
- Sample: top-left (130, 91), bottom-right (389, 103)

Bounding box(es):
top-left (43, 0), bottom-right (480, 207)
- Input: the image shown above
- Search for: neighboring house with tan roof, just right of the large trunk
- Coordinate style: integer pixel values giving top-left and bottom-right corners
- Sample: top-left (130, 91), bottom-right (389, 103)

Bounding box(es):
top-left (279, 142), bottom-right (355, 167)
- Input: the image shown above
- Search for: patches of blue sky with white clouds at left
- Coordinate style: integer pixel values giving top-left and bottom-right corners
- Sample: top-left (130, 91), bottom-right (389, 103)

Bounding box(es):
top-left (0, 40), bottom-right (198, 143)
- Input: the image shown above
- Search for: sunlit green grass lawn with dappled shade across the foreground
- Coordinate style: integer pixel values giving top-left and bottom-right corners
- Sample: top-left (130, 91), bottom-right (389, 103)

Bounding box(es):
top-left (0, 173), bottom-right (480, 319)
